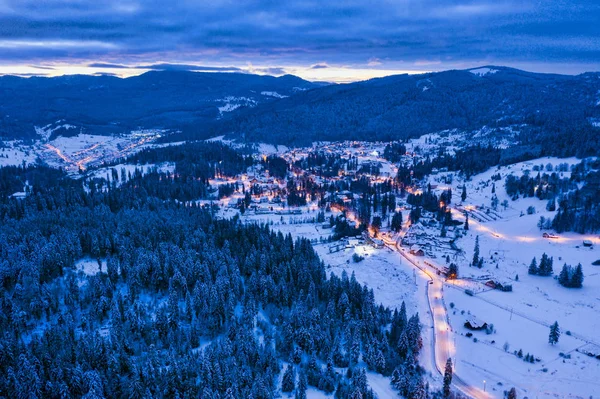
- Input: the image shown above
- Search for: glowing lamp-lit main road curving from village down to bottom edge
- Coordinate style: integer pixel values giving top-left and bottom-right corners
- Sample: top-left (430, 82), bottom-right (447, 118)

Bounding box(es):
top-left (385, 240), bottom-right (493, 399)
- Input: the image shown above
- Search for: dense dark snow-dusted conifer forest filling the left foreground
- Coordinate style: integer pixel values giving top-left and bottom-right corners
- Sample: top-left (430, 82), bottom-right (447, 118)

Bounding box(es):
top-left (0, 164), bottom-right (427, 399)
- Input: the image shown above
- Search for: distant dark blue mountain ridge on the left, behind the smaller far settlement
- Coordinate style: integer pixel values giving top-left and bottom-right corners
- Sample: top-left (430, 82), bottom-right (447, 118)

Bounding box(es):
top-left (0, 71), bottom-right (322, 138)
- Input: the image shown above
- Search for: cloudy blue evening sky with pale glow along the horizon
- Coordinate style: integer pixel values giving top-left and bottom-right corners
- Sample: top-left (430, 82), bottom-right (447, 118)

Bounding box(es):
top-left (0, 0), bottom-right (600, 82)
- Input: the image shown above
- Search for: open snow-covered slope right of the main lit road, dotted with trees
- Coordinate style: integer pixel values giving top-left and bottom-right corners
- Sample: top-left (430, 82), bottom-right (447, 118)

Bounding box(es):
top-left (422, 158), bottom-right (600, 398)
